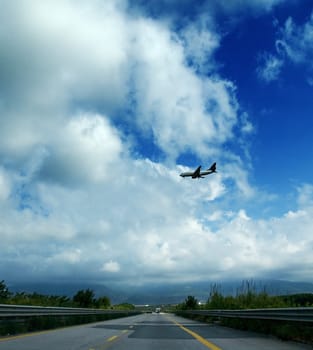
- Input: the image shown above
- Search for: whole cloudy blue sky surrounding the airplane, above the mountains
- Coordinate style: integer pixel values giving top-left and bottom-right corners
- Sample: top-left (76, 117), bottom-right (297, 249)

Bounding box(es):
top-left (0, 0), bottom-right (313, 286)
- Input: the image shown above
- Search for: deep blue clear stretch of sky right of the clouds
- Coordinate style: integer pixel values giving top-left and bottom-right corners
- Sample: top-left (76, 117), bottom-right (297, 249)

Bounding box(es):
top-left (217, 1), bottom-right (313, 211)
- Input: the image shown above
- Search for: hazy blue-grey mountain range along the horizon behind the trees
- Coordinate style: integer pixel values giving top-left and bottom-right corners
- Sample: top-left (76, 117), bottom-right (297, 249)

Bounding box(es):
top-left (8, 280), bottom-right (313, 305)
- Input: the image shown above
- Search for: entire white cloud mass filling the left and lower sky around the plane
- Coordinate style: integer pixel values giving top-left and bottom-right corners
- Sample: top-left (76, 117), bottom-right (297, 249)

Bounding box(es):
top-left (0, 0), bottom-right (312, 288)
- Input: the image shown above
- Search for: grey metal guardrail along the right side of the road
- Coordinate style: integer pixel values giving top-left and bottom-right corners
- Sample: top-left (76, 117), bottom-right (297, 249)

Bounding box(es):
top-left (178, 307), bottom-right (313, 324)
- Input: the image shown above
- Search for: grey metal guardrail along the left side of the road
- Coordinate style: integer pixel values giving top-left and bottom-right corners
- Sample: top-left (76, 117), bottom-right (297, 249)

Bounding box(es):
top-left (0, 304), bottom-right (138, 319)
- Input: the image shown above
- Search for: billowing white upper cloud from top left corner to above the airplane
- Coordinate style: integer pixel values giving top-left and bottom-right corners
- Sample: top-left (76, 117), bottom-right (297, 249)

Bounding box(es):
top-left (0, 0), bottom-right (243, 164)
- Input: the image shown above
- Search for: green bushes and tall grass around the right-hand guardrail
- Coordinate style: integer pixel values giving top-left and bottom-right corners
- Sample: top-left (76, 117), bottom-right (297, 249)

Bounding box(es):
top-left (173, 281), bottom-right (313, 345)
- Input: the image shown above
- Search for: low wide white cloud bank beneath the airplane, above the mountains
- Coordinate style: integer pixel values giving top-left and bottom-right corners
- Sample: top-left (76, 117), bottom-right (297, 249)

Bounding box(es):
top-left (0, 161), bottom-right (313, 283)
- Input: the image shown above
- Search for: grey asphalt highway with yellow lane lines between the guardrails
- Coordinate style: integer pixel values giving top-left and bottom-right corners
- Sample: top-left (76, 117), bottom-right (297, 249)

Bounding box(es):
top-left (0, 314), bottom-right (312, 350)
